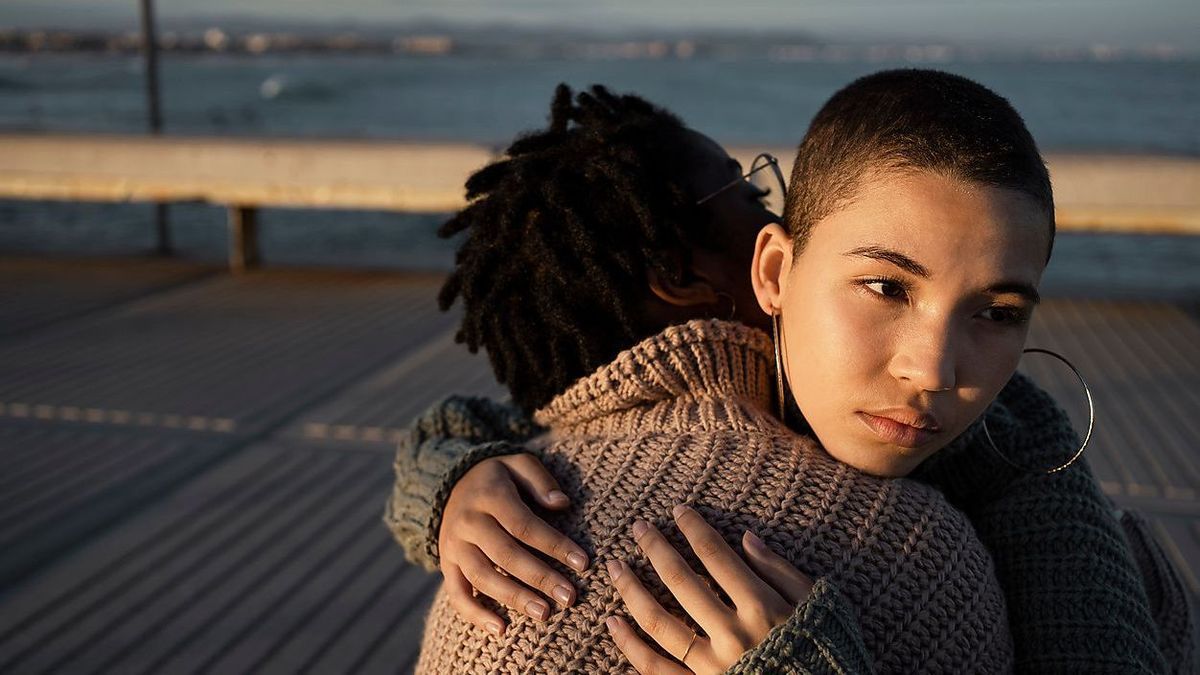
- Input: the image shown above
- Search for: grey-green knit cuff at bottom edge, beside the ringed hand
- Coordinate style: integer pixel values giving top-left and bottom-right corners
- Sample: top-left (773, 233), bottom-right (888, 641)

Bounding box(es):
top-left (726, 579), bottom-right (872, 675)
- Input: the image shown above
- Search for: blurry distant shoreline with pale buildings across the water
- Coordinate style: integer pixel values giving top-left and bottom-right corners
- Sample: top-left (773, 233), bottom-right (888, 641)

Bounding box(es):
top-left (0, 30), bottom-right (1200, 65)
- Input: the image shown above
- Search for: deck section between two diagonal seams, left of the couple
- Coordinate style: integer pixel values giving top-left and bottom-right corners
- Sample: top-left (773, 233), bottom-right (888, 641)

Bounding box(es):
top-left (0, 265), bottom-right (463, 589)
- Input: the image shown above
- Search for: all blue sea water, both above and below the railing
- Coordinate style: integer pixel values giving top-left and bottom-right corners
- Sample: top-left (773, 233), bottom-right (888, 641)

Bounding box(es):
top-left (0, 54), bottom-right (1200, 297)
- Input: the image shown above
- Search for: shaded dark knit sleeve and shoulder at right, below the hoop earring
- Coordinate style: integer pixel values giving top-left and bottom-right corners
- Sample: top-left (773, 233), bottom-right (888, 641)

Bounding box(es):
top-left (919, 374), bottom-right (1190, 674)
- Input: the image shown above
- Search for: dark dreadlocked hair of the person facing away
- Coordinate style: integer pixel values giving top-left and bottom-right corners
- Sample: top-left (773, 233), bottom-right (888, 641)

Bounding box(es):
top-left (438, 84), bottom-right (710, 411)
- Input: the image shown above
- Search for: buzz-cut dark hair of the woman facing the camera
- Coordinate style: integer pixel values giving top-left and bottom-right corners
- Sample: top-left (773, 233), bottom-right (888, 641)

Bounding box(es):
top-left (784, 68), bottom-right (1055, 261)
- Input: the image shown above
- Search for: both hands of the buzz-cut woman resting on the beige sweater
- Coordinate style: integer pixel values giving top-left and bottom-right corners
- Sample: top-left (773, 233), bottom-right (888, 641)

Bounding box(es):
top-left (438, 454), bottom-right (812, 673)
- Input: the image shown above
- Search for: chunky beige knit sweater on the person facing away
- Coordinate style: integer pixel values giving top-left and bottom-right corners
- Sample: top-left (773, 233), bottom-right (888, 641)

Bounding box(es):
top-left (418, 321), bottom-right (1013, 673)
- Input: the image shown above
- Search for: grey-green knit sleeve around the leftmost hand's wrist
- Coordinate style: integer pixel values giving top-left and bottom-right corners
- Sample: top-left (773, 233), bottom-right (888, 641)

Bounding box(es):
top-left (383, 396), bottom-right (538, 572)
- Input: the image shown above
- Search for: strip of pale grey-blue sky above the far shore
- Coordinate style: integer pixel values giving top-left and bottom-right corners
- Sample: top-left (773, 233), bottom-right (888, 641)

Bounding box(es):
top-left (0, 0), bottom-right (1200, 48)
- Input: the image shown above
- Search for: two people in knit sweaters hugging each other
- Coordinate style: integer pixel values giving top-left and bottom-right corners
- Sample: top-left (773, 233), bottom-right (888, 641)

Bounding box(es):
top-left (384, 70), bottom-right (1192, 674)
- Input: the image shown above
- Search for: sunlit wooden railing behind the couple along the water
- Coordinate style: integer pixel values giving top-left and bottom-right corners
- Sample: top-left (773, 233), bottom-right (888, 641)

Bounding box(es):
top-left (0, 135), bottom-right (1200, 270)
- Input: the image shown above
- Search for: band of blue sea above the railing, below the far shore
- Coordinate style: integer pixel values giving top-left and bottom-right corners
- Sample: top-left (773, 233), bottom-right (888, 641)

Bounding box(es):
top-left (0, 54), bottom-right (1200, 155)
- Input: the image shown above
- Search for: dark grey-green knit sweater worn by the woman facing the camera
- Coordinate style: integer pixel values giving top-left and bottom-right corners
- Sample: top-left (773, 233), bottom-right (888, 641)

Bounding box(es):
top-left (385, 317), bottom-right (1194, 673)
